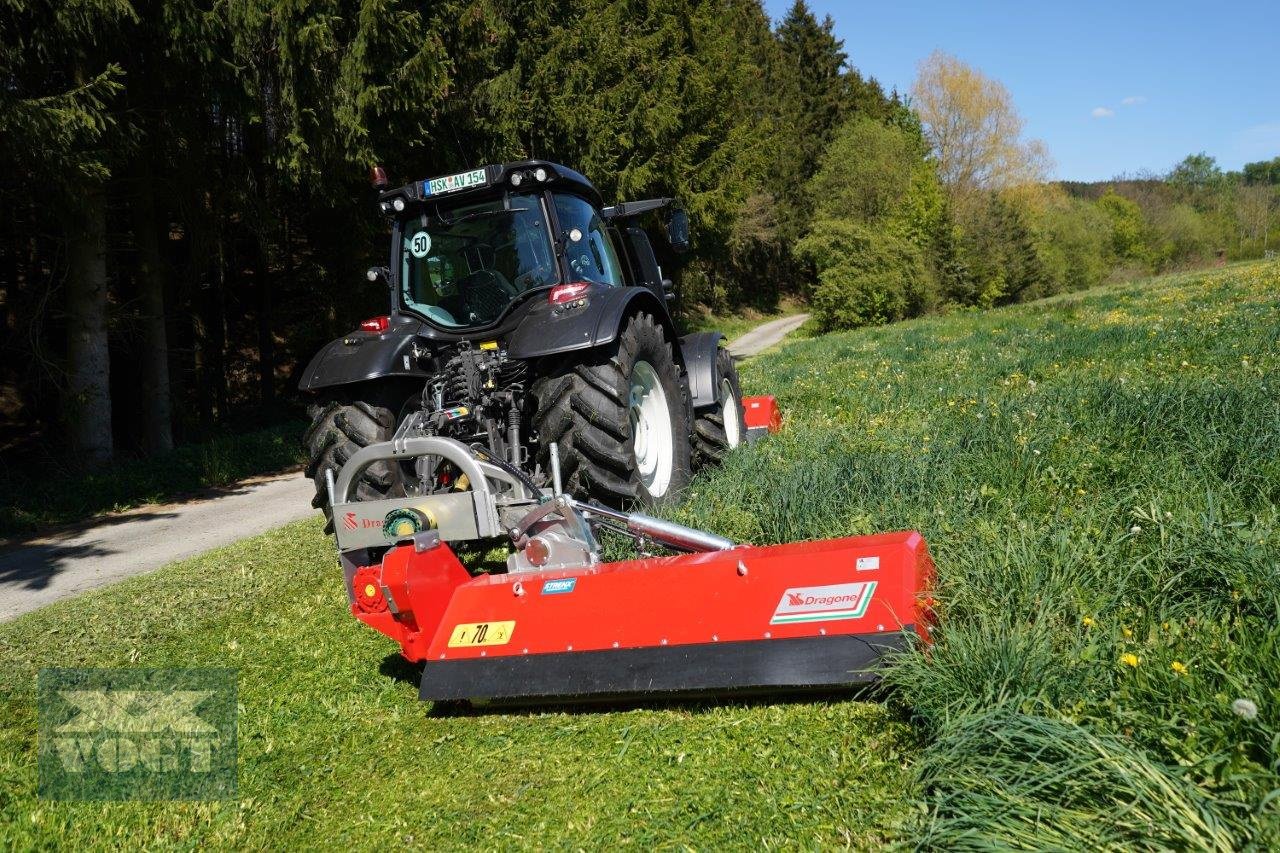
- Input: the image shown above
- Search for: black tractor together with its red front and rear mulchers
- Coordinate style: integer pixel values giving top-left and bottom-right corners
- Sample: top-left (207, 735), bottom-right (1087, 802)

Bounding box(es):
top-left (302, 160), bottom-right (933, 703)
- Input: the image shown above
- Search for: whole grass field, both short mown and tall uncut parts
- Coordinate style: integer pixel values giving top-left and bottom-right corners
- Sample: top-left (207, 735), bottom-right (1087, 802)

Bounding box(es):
top-left (0, 264), bottom-right (1280, 849)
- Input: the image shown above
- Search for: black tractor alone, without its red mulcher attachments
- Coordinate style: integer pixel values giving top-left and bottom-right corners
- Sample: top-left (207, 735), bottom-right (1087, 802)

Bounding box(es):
top-left (301, 160), bottom-right (744, 530)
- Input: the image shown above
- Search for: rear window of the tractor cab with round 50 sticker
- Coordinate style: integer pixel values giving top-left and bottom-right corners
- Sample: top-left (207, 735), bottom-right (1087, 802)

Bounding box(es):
top-left (401, 195), bottom-right (559, 328)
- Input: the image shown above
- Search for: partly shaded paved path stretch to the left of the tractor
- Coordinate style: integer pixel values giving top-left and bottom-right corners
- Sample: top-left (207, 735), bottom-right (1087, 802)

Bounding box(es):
top-left (0, 471), bottom-right (315, 621)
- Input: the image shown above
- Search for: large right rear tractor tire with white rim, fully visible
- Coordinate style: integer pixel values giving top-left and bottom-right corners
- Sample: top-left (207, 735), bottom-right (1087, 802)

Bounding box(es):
top-left (532, 308), bottom-right (690, 506)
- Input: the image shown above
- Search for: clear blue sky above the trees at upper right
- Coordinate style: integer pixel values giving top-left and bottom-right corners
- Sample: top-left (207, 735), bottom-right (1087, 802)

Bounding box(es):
top-left (765, 0), bottom-right (1280, 181)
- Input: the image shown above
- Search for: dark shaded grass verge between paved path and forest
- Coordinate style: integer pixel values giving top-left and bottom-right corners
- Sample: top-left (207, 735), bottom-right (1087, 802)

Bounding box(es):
top-left (0, 421), bottom-right (305, 537)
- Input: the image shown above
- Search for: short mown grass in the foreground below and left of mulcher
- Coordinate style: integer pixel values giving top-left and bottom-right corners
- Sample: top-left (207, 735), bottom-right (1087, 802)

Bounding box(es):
top-left (0, 521), bottom-right (913, 849)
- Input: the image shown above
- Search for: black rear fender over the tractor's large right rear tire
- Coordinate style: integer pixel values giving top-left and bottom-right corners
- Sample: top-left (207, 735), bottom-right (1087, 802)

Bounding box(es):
top-left (507, 286), bottom-right (682, 362)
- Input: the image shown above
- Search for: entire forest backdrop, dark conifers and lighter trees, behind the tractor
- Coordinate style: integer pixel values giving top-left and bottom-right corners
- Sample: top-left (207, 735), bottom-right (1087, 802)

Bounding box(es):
top-left (0, 0), bottom-right (1280, 470)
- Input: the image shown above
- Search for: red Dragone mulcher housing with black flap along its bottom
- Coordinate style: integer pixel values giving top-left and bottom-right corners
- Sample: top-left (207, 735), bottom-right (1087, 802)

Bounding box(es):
top-left (353, 533), bottom-right (932, 701)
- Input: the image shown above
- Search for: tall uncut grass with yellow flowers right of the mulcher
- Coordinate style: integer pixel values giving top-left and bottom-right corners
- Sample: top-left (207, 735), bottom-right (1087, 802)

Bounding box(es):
top-left (686, 264), bottom-right (1280, 849)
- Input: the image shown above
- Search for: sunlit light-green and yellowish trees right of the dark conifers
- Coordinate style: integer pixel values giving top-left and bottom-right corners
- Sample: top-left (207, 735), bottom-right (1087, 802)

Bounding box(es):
top-left (796, 53), bottom-right (1280, 329)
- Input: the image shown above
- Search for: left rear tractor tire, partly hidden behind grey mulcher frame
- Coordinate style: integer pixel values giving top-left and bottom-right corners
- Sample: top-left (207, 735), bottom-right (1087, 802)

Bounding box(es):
top-left (302, 394), bottom-right (403, 533)
